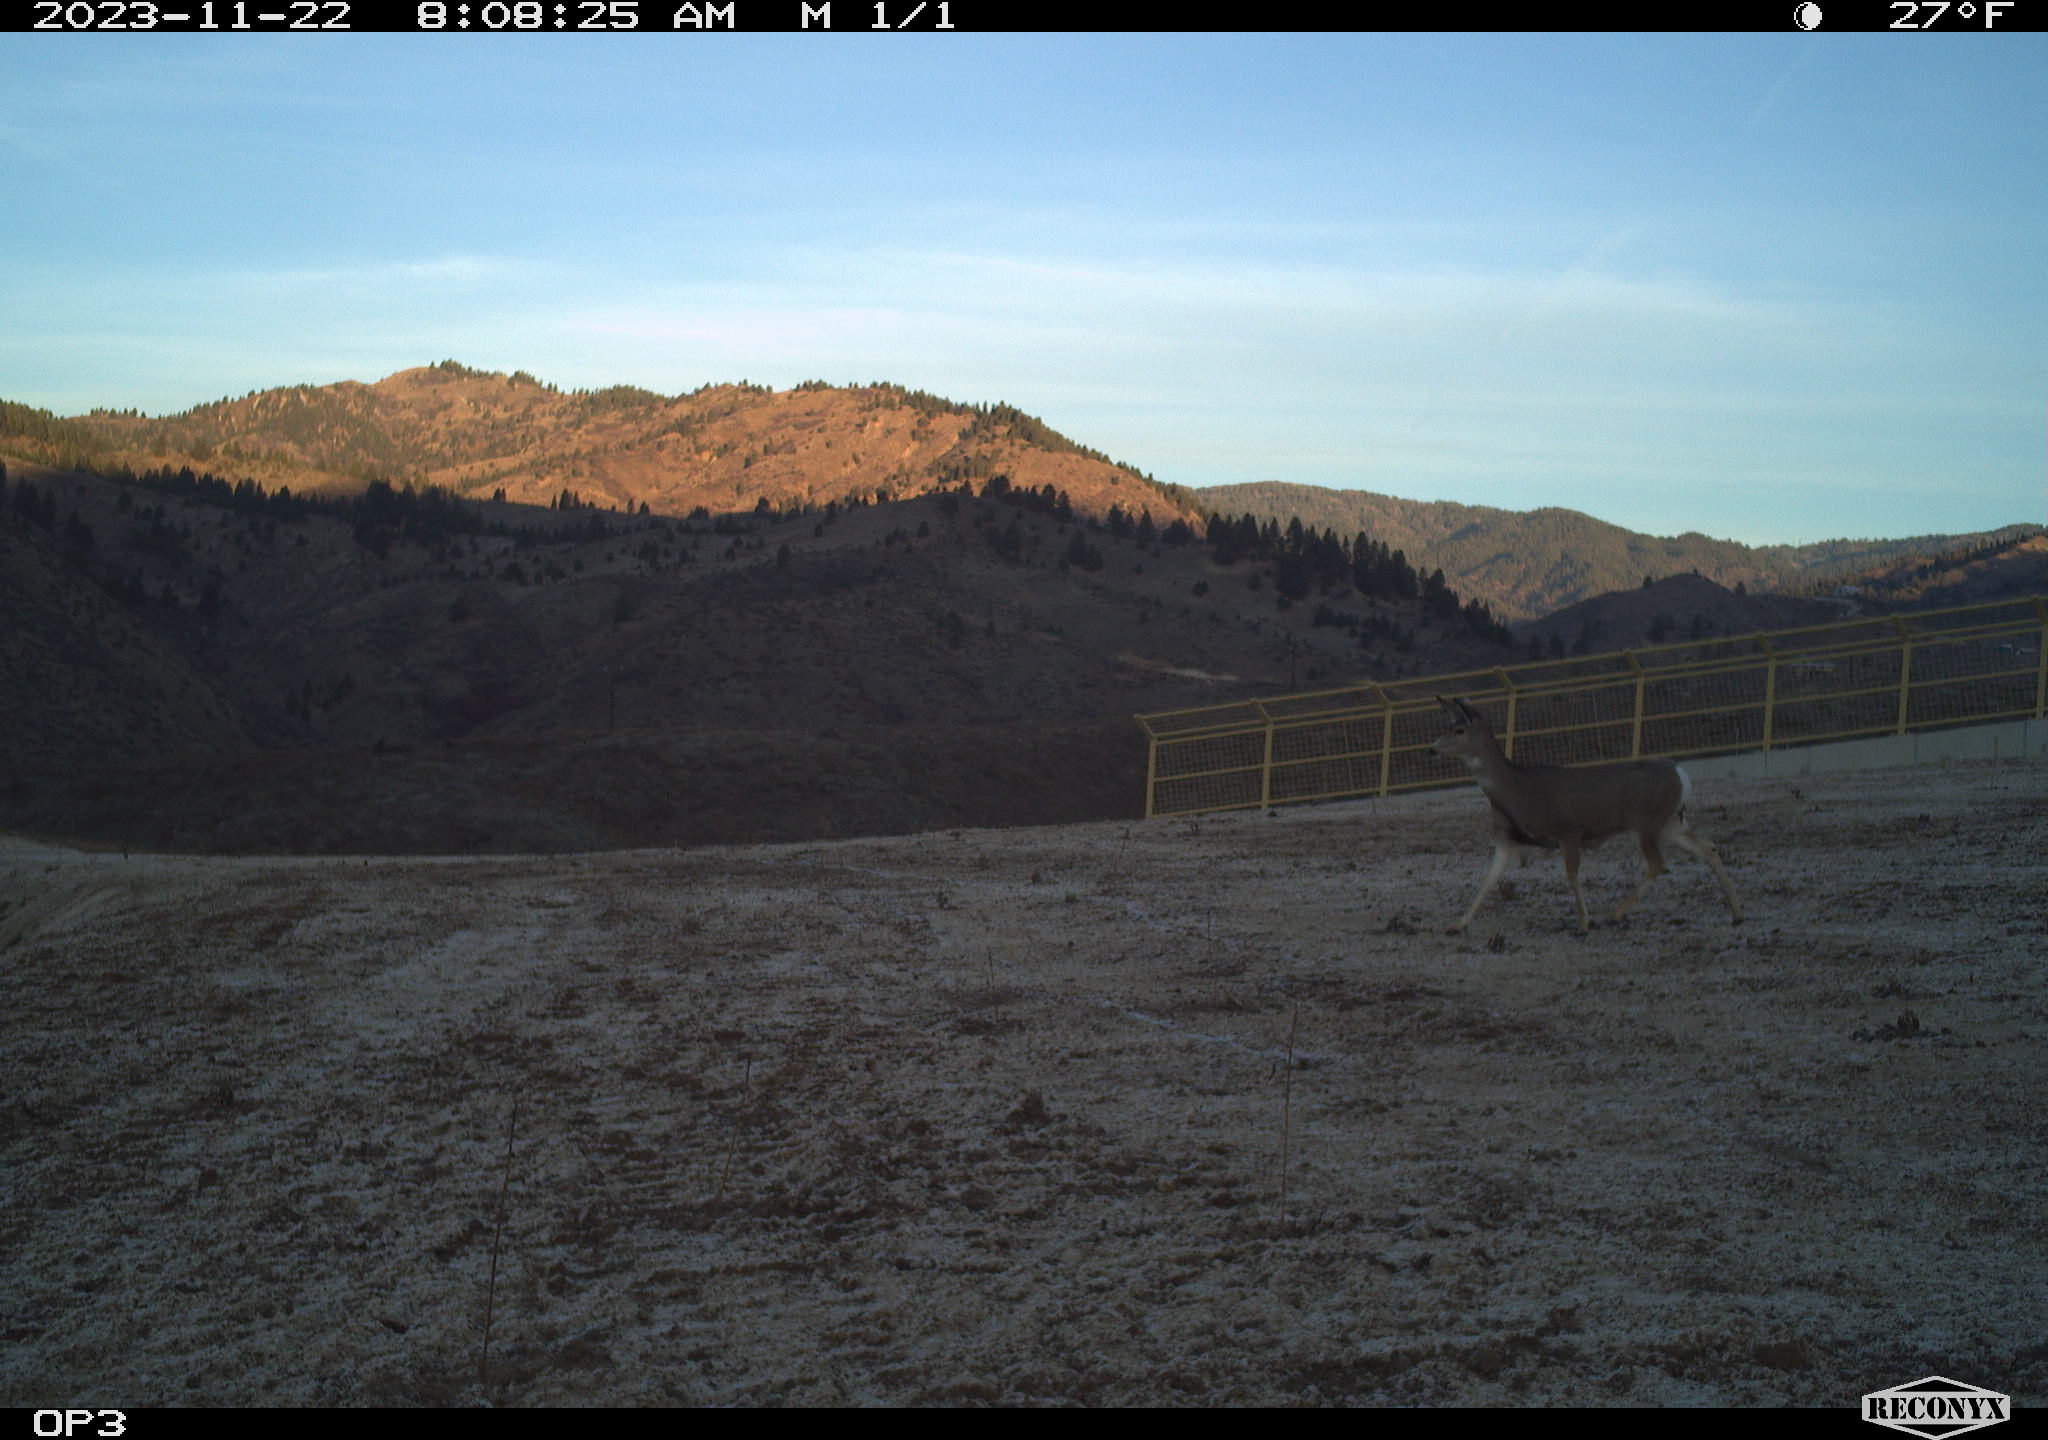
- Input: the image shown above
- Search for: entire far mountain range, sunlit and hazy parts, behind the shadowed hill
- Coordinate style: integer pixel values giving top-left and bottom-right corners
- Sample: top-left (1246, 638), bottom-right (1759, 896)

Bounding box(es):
top-left (12, 361), bottom-right (2040, 623)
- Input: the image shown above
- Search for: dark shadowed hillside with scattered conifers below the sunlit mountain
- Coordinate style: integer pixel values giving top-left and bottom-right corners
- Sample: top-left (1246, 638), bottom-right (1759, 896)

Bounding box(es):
top-left (0, 459), bottom-right (1513, 852)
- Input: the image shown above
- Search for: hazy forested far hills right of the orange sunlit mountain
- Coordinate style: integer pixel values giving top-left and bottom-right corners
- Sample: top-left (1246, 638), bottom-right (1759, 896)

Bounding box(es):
top-left (1194, 481), bottom-right (2040, 619)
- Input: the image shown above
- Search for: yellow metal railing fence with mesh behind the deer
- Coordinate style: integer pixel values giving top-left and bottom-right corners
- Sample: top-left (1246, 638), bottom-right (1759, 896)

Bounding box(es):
top-left (1137, 596), bottom-right (2048, 815)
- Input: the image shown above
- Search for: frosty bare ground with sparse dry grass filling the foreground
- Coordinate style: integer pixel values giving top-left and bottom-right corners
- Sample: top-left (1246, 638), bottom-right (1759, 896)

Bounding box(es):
top-left (0, 762), bottom-right (2048, 1407)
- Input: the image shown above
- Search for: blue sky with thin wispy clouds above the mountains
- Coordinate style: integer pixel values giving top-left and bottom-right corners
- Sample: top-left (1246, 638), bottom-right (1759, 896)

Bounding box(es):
top-left (0, 31), bottom-right (2048, 543)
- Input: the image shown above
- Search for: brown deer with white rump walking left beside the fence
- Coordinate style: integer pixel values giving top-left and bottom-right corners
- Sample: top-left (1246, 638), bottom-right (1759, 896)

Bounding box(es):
top-left (1430, 694), bottom-right (1743, 934)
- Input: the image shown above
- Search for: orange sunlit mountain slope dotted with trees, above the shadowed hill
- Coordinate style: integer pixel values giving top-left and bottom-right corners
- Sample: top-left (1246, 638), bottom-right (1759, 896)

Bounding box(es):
top-left (0, 361), bottom-right (1194, 524)
